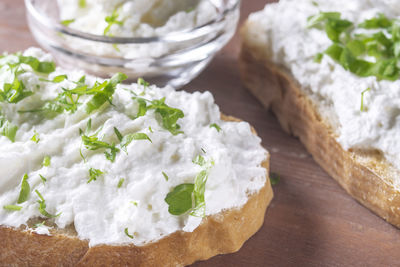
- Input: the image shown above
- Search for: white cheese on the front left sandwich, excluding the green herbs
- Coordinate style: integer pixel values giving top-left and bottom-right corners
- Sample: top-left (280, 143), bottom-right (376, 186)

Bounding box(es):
top-left (0, 48), bottom-right (266, 246)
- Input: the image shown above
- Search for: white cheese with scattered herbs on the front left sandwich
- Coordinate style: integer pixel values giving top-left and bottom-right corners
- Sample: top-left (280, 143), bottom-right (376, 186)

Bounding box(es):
top-left (0, 48), bottom-right (266, 246)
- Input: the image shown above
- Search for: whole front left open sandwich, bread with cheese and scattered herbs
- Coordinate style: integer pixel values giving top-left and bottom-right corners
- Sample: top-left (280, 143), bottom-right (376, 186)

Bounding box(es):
top-left (0, 48), bottom-right (272, 266)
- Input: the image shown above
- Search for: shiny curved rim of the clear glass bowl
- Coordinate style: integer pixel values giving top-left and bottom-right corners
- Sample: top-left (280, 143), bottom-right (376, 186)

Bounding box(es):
top-left (25, 0), bottom-right (241, 44)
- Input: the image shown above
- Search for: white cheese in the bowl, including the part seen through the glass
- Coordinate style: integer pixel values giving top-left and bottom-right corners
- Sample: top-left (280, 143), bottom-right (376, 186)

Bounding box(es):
top-left (57, 0), bottom-right (219, 58)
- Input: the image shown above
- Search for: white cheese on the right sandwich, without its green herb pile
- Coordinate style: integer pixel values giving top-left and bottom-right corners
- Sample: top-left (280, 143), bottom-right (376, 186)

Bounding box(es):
top-left (248, 0), bottom-right (400, 178)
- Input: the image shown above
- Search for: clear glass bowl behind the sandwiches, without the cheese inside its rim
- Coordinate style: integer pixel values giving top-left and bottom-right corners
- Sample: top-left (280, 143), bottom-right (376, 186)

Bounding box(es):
top-left (25, 0), bottom-right (240, 88)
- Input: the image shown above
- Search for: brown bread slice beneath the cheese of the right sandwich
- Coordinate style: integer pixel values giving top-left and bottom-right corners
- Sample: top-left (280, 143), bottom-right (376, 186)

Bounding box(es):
top-left (240, 21), bottom-right (400, 227)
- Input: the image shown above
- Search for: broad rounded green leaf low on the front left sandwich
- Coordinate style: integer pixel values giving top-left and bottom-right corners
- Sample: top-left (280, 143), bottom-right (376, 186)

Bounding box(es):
top-left (165, 184), bottom-right (194, 215)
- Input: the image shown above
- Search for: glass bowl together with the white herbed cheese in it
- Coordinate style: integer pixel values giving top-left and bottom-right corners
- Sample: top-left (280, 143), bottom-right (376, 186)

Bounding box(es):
top-left (25, 0), bottom-right (240, 87)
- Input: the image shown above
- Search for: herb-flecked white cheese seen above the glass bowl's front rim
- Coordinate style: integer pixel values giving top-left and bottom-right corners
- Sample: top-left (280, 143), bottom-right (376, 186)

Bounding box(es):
top-left (57, 0), bottom-right (218, 37)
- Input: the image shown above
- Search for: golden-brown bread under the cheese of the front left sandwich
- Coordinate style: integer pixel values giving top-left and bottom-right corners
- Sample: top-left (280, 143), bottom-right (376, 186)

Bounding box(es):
top-left (0, 115), bottom-right (273, 267)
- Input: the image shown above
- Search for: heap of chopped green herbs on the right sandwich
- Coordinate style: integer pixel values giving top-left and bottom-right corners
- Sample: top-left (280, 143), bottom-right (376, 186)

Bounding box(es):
top-left (307, 12), bottom-right (400, 81)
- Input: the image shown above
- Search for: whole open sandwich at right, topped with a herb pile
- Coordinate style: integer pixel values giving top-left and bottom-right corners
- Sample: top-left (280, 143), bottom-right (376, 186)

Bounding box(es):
top-left (240, 0), bottom-right (400, 227)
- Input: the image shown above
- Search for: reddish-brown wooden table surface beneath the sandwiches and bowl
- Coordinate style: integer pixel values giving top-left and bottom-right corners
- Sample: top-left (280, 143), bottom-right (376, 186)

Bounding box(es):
top-left (0, 0), bottom-right (400, 267)
